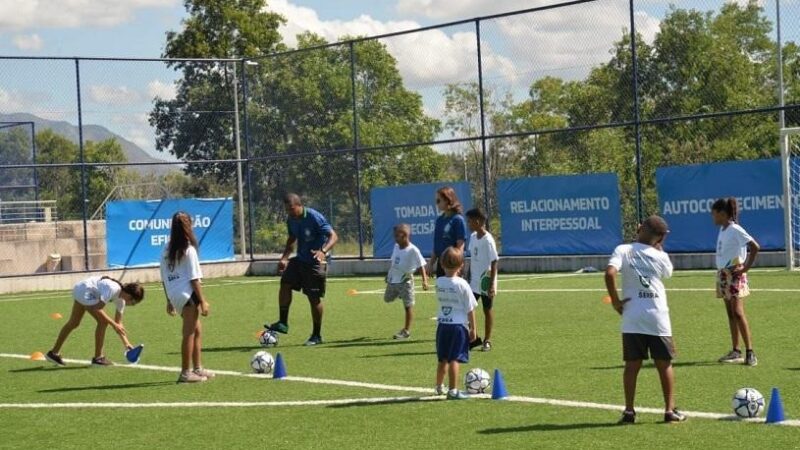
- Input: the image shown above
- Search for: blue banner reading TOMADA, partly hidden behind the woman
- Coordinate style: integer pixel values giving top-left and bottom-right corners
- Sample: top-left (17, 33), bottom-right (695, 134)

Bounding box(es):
top-left (370, 182), bottom-right (472, 258)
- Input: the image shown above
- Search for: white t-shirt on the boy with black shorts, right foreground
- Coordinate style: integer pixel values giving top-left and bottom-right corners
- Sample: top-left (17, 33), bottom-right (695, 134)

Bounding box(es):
top-left (608, 242), bottom-right (672, 336)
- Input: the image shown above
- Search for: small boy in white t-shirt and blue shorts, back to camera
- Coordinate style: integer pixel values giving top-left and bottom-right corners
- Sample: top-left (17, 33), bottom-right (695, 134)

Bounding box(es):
top-left (436, 247), bottom-right (478, 400)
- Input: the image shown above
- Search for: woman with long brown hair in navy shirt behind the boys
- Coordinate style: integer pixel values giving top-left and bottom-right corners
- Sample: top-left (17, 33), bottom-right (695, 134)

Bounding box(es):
top-left (428, 186), bottom-right (467, 277)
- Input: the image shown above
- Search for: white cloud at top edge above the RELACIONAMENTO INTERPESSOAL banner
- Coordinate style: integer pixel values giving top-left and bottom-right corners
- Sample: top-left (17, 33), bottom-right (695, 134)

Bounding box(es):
top-left (395, 0), bottom-right (660, 84)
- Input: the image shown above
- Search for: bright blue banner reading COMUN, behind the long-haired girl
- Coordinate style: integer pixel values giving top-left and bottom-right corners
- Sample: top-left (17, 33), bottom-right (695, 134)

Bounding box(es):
top-left (106, 197), bottom-right (234, 267)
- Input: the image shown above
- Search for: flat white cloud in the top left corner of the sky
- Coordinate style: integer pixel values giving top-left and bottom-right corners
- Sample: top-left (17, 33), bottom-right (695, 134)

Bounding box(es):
top-left (0, 0), bottom-right (179, 30)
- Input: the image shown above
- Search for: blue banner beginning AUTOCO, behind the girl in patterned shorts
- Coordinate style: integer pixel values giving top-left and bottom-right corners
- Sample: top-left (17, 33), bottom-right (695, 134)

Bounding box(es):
top-left (656, 159), bottom-right (800, 252)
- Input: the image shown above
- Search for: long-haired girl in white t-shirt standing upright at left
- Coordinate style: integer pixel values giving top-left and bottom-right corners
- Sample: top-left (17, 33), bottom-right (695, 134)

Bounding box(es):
top-left (161, 211), bottom-right (214, 383)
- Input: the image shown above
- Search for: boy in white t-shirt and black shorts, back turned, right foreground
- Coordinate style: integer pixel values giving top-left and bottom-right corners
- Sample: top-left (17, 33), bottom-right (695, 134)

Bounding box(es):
top-left (605, 216), bottom-right (686, 424)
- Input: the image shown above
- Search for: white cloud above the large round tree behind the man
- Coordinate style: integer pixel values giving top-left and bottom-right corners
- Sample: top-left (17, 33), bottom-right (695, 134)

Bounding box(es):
top-left (268, 0), bottom-right (514, 88)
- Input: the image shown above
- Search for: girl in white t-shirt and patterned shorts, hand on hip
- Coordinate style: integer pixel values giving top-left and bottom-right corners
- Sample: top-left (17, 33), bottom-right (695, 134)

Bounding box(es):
top-left (711, 197), bottom-right (760, 366)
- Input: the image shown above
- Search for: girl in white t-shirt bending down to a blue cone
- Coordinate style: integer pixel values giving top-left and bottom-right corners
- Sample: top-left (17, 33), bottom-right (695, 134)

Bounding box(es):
top-left (45, 276), bottom-right (144, 366)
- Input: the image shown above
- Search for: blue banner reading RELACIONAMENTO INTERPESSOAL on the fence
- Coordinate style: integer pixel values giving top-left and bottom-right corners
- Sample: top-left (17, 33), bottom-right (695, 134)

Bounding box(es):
top-left (497, 173), bottom-right (622, 255)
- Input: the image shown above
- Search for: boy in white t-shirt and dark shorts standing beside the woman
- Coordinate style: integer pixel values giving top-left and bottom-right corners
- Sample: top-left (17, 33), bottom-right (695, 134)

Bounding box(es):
top-left (465, 208), bottom-right (500, 352)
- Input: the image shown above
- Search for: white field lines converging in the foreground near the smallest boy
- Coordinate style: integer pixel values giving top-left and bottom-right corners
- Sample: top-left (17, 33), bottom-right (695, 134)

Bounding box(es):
top-left (0, 353), bottom-right (800, 427)
